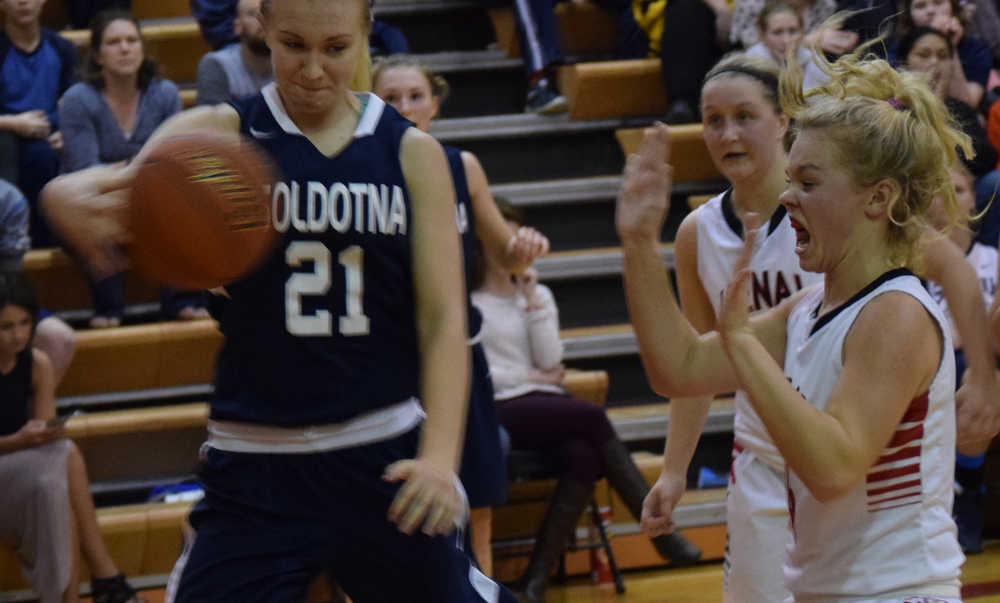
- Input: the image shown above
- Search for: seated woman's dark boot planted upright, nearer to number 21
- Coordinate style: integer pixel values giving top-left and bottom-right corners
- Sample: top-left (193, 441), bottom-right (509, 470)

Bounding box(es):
top-left (511, 477), bottom-right (594, 603)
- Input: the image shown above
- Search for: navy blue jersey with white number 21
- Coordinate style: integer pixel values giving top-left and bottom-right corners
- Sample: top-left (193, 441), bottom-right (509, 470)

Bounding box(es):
top-left (212, 84), bottom-right (419, 426)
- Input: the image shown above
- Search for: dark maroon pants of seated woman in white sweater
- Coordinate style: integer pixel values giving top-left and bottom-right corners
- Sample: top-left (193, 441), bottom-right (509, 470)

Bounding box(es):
top-left (497, 392), bottom-right (616, 483)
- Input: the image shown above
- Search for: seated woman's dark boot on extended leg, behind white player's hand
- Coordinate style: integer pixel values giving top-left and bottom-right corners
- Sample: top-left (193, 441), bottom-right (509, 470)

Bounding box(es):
top-left (603, 438), bottom-right (701, 566)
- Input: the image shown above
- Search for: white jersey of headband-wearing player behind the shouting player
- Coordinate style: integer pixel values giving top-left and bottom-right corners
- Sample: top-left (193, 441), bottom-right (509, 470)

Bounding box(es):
top-left (694, 189), bottom-right (823, 471)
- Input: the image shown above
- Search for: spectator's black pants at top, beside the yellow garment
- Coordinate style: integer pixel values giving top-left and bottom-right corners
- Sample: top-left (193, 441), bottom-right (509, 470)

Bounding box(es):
top-left (660, 0), bottom-right (722, 102)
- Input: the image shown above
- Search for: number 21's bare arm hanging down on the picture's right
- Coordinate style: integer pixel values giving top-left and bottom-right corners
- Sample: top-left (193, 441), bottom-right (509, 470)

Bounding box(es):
top-left (385, 128), bottom-right (469, 534)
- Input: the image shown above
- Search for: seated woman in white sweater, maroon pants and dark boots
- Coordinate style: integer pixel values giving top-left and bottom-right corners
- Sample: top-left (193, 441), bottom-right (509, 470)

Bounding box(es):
top-left (472, 203), bottom-right (701, 602)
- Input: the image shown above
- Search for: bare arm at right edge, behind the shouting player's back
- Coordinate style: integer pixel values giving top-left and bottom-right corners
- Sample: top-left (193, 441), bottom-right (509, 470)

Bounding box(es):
top-left (922, 232), bottom-right (1000, 455)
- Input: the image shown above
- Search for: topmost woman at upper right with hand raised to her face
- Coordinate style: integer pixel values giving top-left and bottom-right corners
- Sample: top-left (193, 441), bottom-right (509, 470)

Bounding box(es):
top-left (889, 0), bottom-right (993, 109)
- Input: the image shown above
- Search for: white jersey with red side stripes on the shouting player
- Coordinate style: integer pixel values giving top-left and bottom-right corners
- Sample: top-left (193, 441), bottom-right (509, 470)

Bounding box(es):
top-left (785, 269), bottom-right (964, 601)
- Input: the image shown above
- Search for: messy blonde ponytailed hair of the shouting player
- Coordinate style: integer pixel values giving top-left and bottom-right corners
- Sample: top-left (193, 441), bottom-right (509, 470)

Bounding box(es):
top-left (780, 22), bottom-right (973, 268)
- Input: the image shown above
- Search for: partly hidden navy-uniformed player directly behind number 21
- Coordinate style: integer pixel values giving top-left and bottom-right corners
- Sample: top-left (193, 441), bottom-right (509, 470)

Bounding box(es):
top-left (372, 54), bottom-right (549, 576)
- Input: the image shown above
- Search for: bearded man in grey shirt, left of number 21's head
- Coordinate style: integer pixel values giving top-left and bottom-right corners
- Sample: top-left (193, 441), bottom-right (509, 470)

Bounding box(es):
top-left (198, 0), bottom-right (274, 105)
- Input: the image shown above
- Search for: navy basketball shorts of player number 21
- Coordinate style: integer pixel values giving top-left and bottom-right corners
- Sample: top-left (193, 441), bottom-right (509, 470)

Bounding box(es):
top-left (167, 429), bottom-right (515, 603)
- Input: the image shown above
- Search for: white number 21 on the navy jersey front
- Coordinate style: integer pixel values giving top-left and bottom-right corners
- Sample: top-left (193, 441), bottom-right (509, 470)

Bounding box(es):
top-left (285, 241), bottom-right (368, 337)
